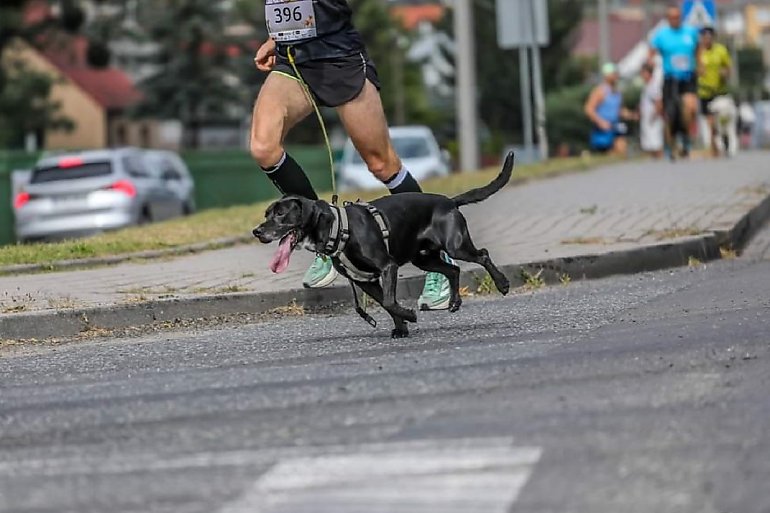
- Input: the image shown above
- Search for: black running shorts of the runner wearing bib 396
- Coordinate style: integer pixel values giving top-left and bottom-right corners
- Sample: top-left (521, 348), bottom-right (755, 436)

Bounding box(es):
top-left (272, 52), bottom-right (380, 107)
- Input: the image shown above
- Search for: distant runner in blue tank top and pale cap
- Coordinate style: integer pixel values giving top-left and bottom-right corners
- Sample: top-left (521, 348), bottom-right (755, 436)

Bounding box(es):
top-left (583, 62), bottom-right (637, 156)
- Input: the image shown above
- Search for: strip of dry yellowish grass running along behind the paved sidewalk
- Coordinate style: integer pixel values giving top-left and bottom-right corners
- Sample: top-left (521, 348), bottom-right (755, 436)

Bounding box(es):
top-left (0, 157), bottom-right (617, 270)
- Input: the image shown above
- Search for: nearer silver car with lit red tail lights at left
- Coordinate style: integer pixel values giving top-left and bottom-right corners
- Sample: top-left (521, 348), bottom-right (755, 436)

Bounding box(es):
top-left (13, 148), bottom-right (194, 241)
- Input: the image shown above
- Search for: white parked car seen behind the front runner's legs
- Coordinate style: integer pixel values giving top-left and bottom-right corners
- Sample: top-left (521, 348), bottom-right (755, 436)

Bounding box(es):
top-left (337, 126), bottom-right (450, 190)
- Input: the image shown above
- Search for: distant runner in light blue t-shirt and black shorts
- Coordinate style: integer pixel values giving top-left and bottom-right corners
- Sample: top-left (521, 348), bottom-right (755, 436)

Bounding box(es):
top-left (648, 4), bottom-right (699, 158)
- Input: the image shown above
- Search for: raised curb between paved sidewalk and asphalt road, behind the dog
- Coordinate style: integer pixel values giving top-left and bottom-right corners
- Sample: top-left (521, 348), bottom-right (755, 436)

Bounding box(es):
top-left (0, 184), bottom-right (770, 339)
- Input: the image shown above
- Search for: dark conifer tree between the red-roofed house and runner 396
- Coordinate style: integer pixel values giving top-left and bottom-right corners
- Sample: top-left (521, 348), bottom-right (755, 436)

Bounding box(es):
top-left (139, 0), bottom-right (245, 148)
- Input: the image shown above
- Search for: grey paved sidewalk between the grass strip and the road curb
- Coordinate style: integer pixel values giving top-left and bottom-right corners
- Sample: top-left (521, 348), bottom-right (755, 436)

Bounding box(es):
top-left (0, 153), bottom-right (770, 338)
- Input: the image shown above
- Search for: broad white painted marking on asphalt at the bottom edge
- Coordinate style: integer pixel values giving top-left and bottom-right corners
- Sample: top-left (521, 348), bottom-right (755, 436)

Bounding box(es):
top-left (220, 439), bottom-right (542, 513)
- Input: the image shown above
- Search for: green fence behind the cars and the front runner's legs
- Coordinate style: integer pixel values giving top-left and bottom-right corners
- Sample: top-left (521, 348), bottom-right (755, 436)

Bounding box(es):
top-left (0, 146), bottom-right (331, 245)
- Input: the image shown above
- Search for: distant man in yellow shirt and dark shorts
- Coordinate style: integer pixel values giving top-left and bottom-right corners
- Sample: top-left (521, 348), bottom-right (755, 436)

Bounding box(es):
top-left (698, 27), bottom-right (732, 155)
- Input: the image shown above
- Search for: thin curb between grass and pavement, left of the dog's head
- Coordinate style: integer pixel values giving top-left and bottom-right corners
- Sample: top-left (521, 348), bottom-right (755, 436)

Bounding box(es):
top-left (0, 234), bottom-right (254, 276)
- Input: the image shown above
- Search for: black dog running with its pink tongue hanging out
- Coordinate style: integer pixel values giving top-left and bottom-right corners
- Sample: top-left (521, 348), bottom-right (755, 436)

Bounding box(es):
top-left (253, 153), bottom-right (513, 338)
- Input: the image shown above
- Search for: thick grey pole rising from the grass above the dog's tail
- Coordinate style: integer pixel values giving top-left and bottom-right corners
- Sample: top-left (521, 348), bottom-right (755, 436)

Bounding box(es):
top-left (454, 0), bottom-right (479, 171)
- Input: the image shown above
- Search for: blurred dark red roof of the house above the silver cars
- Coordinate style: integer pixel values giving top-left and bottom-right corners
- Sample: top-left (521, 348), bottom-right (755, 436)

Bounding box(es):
top-left (43, 36), bottom-right (142, 110)
